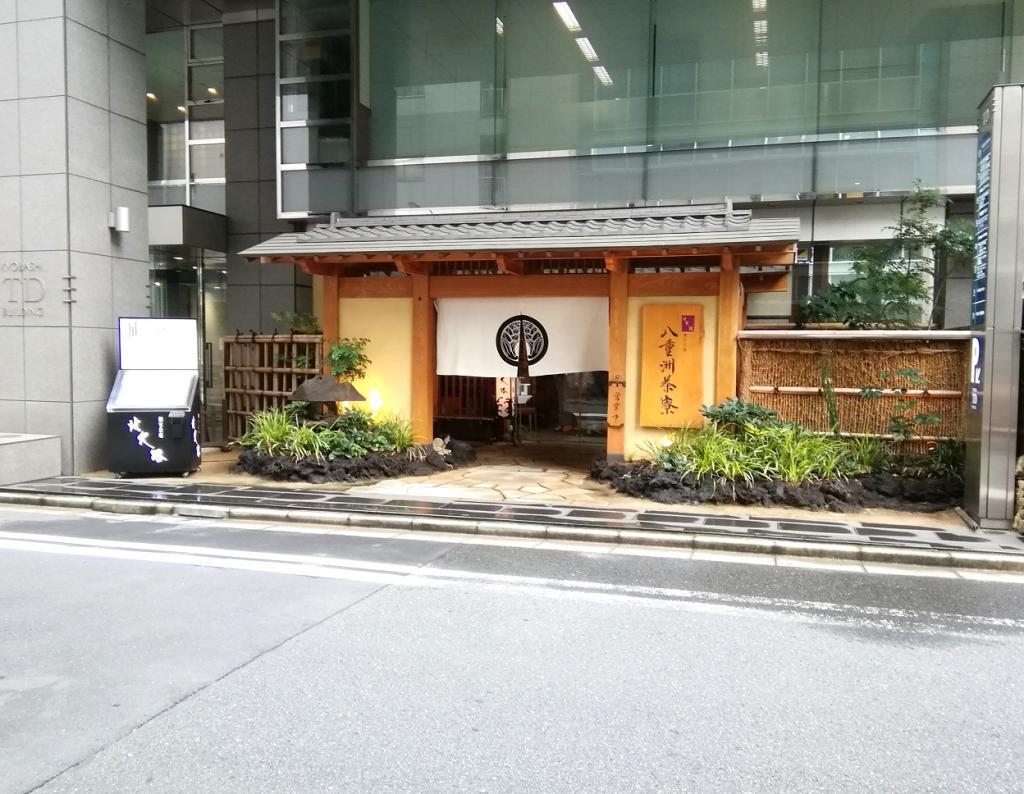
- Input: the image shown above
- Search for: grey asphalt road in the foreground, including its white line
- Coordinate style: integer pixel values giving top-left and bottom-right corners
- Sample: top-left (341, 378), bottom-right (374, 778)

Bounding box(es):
top-left (0, 509), bottom-right (1024, 793)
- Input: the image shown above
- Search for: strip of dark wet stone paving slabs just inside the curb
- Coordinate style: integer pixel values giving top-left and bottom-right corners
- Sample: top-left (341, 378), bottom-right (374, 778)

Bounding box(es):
top-left (0, 476), bottom-right (1024, 556)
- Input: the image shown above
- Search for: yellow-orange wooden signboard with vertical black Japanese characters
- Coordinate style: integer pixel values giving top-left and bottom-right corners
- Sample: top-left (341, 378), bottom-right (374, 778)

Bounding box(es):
top-left (640, 303), bottom-right (703, 427)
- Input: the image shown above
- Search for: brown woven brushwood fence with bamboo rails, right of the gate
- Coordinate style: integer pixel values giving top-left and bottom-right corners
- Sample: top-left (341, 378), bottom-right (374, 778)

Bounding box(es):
top-left (738, 332), bottom-right (970, 441)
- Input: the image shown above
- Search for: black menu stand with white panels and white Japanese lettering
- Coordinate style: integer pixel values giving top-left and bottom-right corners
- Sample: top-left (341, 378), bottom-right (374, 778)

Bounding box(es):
top-left (106, 318), bottom-right (201, 476)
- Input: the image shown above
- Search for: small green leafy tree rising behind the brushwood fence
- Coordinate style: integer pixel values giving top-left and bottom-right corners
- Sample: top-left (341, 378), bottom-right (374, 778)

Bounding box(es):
top-left (797, 183), bottom-right (974, 328)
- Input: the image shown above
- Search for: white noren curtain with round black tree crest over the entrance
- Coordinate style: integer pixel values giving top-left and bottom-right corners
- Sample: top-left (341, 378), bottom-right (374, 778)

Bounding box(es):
top-left (437, 298), bottom-right (608, 378)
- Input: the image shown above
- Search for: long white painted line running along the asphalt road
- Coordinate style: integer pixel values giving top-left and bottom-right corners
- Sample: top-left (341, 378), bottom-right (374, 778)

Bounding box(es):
top-left (0, 533), bottom-right (1024, 633)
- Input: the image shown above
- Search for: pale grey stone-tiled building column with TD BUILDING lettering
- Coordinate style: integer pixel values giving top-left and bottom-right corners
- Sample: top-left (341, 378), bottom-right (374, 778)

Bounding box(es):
top-left (0, 2), bottom-right (150, 474)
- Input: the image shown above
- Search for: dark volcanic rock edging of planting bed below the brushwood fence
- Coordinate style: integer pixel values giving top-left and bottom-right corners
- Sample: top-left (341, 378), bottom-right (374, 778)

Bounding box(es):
top-left (590, 460), bottom-right (964, 512)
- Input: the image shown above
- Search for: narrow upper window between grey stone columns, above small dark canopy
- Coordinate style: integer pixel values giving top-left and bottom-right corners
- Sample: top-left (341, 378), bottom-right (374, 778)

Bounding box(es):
top-left (146, 25), bottom-right (224, 214)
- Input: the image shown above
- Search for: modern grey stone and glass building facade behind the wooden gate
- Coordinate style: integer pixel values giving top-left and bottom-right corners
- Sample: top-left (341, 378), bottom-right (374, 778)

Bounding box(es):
top-left (0, 0), bottom-right (1024, 472)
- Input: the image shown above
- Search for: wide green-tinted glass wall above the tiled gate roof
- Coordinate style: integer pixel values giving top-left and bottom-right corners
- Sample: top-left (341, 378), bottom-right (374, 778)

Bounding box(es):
top-left (280, 0), bottom-right (1007, 214)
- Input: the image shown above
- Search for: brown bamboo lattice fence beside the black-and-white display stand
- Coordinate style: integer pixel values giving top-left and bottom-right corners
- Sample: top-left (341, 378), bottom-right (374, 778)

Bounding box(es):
top-left (223, 334), bottom-right (324, 438)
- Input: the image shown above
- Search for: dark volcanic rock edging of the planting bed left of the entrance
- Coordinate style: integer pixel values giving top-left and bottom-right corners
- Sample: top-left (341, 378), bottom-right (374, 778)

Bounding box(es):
top-left (232, 442), bottom-right (476, 485)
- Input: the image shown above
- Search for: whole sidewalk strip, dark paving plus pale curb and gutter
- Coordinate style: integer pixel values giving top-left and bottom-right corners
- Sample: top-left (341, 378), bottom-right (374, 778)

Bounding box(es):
top-left (0, 476), bottom-right (1024, 572)
